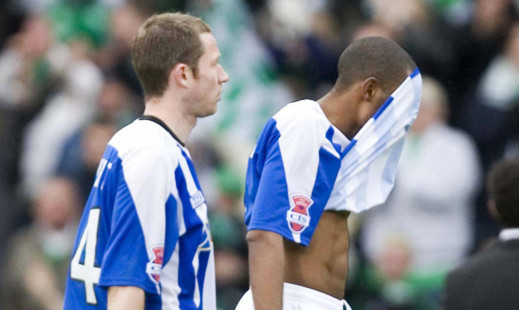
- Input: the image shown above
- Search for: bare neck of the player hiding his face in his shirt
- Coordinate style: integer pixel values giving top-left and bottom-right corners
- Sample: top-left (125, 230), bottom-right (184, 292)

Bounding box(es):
top-left (318, 90), bottom-right (359, 139)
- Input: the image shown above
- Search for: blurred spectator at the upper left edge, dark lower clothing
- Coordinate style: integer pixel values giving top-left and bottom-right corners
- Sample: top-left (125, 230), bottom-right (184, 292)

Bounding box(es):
top-left (0, 13), bottom-right (67, 190)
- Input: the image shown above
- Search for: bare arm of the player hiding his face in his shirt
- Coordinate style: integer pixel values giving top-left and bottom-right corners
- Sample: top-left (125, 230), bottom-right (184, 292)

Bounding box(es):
top-left (247, 230), bottom-right (285, 310)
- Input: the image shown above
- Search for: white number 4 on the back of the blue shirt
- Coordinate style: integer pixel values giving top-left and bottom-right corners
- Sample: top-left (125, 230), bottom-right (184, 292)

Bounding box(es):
top-left (70, 208), bottom-right (101, 305)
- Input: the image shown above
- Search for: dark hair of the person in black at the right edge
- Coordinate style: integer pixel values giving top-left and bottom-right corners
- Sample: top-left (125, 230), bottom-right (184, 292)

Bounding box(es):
top-left (487, 158), bottom-right (519, 227)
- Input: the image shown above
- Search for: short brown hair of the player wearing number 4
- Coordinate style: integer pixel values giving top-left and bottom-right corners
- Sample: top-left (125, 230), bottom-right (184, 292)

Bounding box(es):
top-left (132, 13), bottom-right (211, 98)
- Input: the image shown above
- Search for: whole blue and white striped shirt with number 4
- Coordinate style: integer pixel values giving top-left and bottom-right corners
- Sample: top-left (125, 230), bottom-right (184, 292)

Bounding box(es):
top-left (64, 117), bottom-right (216, 309)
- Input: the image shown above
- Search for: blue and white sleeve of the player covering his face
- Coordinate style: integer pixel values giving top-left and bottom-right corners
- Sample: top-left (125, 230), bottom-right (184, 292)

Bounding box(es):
top-left (245, 100), bottom-right (347, 246)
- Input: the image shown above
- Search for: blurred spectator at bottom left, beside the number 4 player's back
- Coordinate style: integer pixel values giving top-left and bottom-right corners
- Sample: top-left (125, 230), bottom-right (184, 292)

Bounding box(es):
top-left (0, 177), bottom-right (81, 310)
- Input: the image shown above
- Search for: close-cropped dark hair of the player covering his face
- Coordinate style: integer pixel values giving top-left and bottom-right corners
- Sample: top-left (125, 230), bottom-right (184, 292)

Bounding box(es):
top-left (335, 37), bottom-right (416, 92)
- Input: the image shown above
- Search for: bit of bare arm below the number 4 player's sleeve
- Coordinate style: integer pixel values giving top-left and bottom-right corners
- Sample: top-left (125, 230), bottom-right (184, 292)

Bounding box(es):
top-left (107, 286), bottom-right (144, 310)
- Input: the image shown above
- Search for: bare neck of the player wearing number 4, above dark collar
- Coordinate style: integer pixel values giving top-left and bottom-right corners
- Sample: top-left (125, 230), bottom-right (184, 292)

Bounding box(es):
top-left (144, 97), bottom-right (196, 143)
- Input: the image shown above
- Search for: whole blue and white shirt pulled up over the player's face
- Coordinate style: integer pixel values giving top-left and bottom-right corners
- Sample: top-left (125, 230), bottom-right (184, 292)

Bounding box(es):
top-left (245, 69), bottom-right (422, 246)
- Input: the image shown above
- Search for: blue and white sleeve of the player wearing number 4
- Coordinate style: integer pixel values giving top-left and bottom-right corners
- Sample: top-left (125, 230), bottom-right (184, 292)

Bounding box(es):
top-left (99, 147), bottom-right (178, 294)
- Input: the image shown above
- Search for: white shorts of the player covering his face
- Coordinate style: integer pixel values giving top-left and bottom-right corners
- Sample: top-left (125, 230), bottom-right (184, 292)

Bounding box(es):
top-left (236, 283), bottom-right (351, 310)
